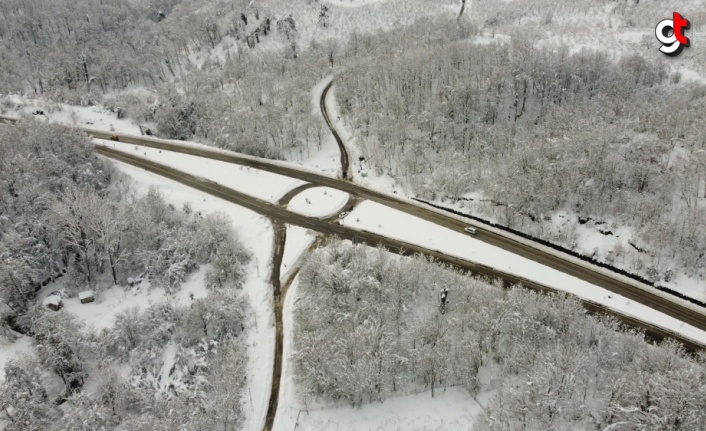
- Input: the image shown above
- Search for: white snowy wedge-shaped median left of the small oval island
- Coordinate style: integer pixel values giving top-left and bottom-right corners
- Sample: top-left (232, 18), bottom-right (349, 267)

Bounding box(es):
top-left (96, 140), bottom-right (305, 203)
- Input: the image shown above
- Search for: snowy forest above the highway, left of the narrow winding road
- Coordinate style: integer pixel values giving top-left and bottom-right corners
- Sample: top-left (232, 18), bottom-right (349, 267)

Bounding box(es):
top-left (0, 0), bottom-right (338, 159)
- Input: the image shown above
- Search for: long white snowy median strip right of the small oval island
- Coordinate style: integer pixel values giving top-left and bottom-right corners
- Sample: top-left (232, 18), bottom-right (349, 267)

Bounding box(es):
top-left (342, 201), bottom-right (706, 344)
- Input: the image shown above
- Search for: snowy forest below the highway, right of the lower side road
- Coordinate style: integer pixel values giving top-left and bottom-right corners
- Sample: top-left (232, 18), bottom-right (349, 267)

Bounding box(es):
top-left (294, 242), bottom-right (706, 430)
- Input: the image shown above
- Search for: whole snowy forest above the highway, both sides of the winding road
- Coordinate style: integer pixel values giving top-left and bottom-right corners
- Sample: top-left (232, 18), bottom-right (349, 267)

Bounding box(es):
top-left (0, 0), bottom-right (706, 296)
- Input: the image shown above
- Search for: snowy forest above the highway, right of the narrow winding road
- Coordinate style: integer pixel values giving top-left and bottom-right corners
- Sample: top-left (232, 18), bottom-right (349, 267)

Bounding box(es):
top-left (336, 13), bottom-right (706, 288)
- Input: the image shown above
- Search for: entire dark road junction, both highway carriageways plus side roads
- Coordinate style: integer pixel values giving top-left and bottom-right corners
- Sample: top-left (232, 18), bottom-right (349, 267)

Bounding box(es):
top-left (0, 81), bottom-right (706, 430)
